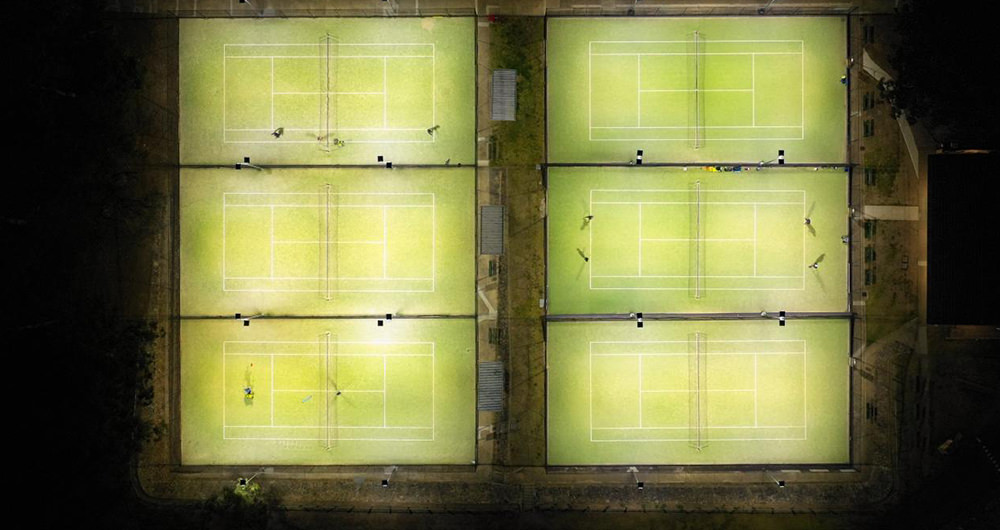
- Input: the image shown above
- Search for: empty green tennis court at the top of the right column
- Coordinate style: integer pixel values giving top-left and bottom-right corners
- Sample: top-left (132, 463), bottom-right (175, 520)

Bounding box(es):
top-left (546, 17), bottom-right (847, 163)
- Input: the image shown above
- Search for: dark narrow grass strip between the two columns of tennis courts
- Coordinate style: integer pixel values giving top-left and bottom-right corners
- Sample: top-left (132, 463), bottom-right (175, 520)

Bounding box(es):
top-left (490, 17), bottom-right (545, 466)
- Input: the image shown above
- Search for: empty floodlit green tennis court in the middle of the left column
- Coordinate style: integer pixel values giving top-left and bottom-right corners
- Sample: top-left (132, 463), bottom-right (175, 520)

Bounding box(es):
top-left (180, 168), bottom-right (475, 316)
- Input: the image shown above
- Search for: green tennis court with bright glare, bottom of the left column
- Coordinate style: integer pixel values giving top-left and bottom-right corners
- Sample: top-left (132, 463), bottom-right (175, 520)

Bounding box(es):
top-left (180, 319), bottom-right (476, 465)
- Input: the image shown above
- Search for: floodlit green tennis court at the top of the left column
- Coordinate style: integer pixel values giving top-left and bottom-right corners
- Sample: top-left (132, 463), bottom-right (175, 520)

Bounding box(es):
top-left (180, 18), bottom-right (476, 164)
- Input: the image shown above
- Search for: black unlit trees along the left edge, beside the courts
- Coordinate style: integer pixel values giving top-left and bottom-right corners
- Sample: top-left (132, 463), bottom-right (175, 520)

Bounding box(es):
top-left (6, 0), bottom-right (168, 528)
